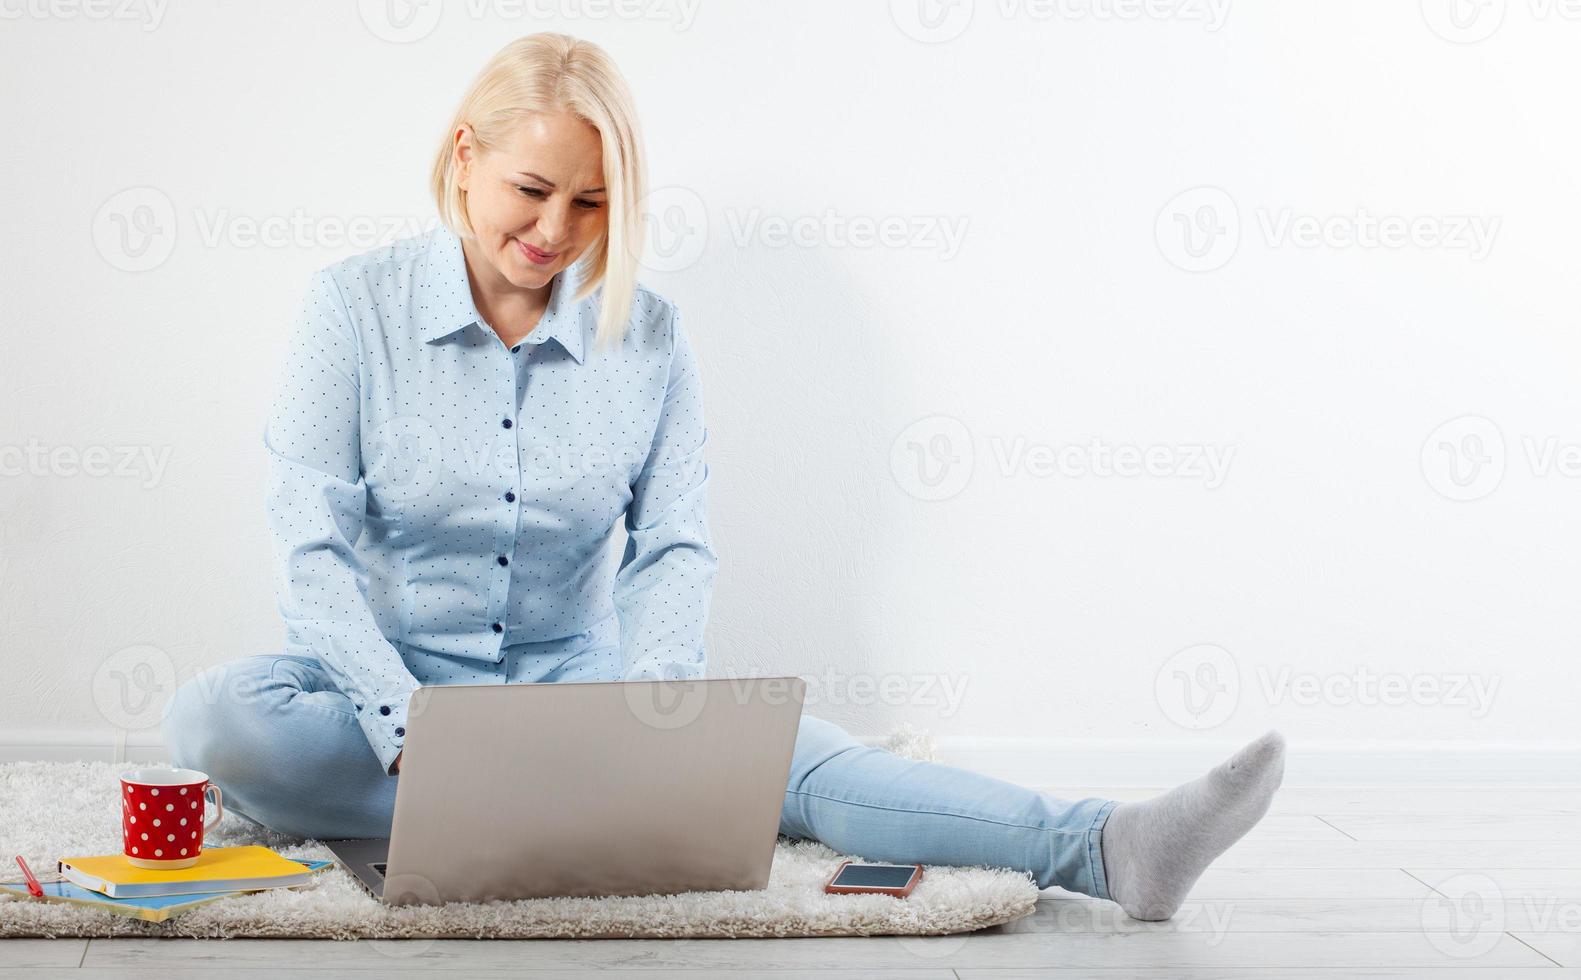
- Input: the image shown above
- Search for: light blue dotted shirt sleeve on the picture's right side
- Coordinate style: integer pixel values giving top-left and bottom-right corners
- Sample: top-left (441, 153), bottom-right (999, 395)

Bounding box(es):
top-left (615, 307), bottom-right (718, 680)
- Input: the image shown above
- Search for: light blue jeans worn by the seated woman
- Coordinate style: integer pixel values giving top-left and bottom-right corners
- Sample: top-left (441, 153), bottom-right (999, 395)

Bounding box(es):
top-left (164, 654), bottom-right (1115, 898)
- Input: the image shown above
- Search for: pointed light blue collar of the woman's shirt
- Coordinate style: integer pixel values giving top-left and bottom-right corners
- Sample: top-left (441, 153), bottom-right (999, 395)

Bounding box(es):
top-left (417, 224), bottom-right (593, 364)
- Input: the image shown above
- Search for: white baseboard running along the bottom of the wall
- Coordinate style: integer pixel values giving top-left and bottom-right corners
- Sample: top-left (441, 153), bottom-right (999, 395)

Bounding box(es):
top-left (0, 730), bottom-right (1581, 789)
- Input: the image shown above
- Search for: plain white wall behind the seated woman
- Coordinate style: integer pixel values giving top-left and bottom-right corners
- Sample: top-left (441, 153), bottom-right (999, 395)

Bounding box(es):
top-left (0, 0), bottom-right (1581, 780)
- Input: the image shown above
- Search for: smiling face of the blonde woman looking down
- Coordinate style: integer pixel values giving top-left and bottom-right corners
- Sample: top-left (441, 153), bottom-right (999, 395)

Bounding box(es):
top-left (455, 112), bottom-right (609, 289)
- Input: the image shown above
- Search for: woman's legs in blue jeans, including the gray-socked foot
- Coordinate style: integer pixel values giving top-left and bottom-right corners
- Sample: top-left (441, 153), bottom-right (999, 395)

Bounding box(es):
top-left (164, 656), bottom-right (1284, 918)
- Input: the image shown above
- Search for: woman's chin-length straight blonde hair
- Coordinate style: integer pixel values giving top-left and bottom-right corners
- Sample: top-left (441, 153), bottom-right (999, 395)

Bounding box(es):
top-left (432, 32), bottom-right (647, 352)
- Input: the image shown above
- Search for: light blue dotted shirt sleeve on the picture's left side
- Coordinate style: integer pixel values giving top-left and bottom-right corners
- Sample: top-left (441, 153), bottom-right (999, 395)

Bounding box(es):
top-left (264, 270), bottom-right (419, 773)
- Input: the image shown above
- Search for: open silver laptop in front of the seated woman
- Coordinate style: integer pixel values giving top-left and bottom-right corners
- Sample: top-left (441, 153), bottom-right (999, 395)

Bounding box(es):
top-left (326, 677), bottom-right (806, 906)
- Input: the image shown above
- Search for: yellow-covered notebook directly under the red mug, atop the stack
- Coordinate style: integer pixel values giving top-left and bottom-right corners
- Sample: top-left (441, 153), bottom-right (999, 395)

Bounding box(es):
top-left (60, 844), bottom-right (313, 898)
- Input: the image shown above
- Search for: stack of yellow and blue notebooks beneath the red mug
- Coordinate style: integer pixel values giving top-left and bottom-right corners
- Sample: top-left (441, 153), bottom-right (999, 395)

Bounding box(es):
top-left (0, 846), bottom-right (330, 922)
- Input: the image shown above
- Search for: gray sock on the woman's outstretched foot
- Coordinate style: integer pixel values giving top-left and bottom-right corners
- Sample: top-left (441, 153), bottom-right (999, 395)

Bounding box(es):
top-left (1099, 732), bottom-right (1284, 920)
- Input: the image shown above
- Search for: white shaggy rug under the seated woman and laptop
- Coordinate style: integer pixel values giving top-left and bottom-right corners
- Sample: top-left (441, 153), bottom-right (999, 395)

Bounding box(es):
top-left (0, 729), bottom-right (1037, 939)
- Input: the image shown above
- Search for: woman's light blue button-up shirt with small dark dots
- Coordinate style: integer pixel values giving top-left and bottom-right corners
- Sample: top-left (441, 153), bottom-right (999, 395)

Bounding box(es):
top-left (264, 226), bottom-right (716, 771)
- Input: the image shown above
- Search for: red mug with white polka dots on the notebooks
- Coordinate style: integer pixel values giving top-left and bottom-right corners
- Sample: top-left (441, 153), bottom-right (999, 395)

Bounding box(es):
top-left (120, 768), bottom-right (225, 871)
